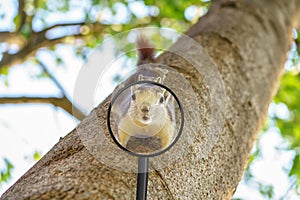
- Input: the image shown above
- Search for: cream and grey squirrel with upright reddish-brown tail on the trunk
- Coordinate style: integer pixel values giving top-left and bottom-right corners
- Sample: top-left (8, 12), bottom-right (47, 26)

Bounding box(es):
top-left (113, 36), bottom-right (175, 149)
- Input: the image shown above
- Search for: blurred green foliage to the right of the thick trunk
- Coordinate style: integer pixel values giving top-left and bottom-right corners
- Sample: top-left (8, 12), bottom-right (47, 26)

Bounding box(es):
top-left (243, 31), bottom-right (300, 199)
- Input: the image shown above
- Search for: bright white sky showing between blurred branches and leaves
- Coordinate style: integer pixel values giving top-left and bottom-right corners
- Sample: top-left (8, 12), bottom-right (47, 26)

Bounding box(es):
top-left (0, 0), bottom-right (297, 200)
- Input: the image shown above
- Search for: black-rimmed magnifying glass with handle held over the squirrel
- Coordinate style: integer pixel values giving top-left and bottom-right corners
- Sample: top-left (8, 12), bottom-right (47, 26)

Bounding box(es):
top-left (107, 80), bottom-right (184, 200)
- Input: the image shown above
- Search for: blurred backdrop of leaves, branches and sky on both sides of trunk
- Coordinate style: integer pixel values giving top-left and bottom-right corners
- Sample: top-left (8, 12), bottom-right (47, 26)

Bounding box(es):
top-left (0, 0), bottom-right (300, 200)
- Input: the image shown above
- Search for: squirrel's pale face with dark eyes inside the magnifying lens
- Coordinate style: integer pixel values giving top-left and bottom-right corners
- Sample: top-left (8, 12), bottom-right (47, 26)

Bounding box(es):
top-left (129, 88), bottom-right (168, 126)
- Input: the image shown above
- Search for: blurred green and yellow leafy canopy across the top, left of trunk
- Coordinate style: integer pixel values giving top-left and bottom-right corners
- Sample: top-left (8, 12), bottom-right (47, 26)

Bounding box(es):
top-left (0, 0), bottom-right (210, 80)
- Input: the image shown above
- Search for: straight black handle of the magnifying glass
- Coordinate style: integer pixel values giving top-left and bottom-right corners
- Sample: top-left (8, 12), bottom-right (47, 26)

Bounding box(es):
top-left (136, 157), bottom-right (149, 200)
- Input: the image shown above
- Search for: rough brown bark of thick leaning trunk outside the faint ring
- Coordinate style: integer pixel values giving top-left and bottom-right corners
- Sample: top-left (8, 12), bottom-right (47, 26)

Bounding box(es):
top-left (1, 0), bottom-right (300, 199)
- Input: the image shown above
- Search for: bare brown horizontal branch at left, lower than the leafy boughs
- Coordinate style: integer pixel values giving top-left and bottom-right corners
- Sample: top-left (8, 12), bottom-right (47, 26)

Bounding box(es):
top-left (0, 96), bottom-right (85, 120)
